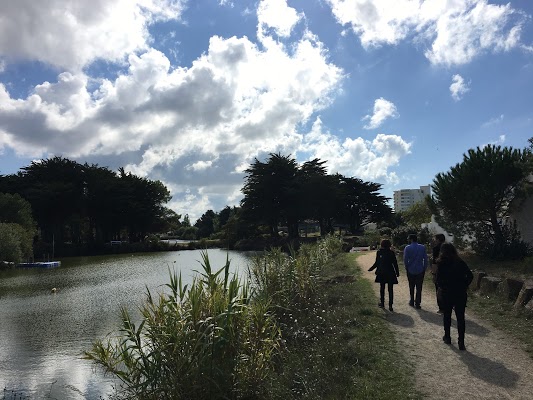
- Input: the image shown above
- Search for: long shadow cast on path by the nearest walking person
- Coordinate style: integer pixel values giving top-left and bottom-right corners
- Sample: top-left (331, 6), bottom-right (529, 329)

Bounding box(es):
top-left (454, 348), bottom-right (520, 388)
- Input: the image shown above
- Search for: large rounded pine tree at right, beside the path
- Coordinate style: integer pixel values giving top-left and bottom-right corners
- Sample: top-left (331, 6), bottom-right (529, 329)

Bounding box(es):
top-left (428, 145), bottom-right (532, 256)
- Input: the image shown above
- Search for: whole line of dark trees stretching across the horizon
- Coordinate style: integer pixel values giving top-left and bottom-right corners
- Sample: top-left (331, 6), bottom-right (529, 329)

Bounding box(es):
top-left (0, 138), bottom-right (533, 259)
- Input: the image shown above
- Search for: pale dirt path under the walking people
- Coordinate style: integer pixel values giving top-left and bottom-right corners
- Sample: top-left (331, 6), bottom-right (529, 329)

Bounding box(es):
top-left (357, 252), bottom-right (533, 400)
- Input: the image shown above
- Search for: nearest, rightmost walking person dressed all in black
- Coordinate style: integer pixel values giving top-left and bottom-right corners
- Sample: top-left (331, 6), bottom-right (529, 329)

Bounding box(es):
top-left (436, 243), bottom-right (474, 350)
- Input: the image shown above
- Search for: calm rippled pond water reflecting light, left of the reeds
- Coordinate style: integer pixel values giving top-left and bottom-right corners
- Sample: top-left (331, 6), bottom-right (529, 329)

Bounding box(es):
top-left (0, 249), bottom-right (251, 400)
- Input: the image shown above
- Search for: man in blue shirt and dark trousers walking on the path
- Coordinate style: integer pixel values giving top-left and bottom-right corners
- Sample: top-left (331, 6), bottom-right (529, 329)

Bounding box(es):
top-left (403, 234), bottom-right (429, 309)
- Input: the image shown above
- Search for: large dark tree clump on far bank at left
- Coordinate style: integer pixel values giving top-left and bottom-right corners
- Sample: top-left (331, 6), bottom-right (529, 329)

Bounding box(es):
top-left (0, 157), bottom-right (170, 251)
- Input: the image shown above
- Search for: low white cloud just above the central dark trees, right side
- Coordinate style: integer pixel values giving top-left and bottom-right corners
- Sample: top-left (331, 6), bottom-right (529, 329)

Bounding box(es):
top-left (300, 119), bottom-right (411, 183)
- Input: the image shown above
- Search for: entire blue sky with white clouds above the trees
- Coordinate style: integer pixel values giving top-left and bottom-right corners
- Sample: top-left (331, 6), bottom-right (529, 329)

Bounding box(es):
top-left (0, 0), bottom-right (533, 221)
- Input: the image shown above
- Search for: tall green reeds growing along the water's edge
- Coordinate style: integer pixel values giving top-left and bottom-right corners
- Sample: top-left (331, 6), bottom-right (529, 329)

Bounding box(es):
top-left (85, 237), bottom-right (342, 400)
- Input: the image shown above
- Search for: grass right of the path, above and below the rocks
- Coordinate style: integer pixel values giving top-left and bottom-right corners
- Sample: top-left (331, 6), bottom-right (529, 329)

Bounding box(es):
top-left (462, 255), bottom-right (533, 357)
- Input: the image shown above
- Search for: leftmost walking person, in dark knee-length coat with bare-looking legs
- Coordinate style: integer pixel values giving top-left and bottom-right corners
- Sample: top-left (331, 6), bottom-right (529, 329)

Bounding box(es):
top-left (369, 239), bottom-right (400, 312)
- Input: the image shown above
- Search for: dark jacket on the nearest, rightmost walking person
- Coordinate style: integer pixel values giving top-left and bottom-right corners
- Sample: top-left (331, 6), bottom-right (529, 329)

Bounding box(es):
top-left (435, 258), bottom-right (474, 297)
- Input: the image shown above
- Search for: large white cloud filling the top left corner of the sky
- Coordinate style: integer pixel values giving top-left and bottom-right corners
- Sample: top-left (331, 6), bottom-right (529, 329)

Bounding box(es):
top-left (0, 0), bottom-right (185, 71)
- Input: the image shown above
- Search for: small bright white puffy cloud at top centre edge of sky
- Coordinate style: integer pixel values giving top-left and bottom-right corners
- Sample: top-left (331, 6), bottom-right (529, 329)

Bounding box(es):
top-left (257, 0), bottom-right (303, 38)
